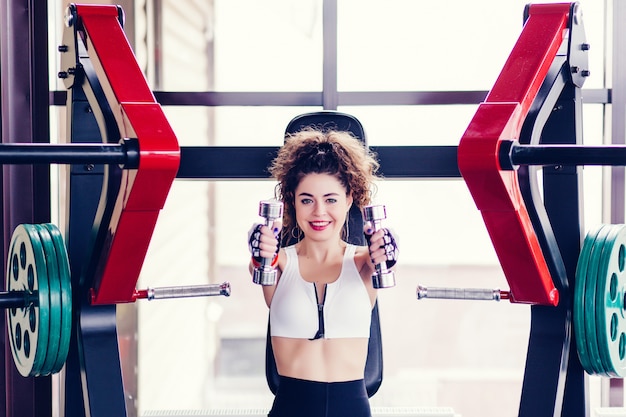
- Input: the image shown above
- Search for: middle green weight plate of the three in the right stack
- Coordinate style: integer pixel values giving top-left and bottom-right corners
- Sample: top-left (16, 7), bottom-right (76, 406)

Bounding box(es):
top-left (584, 225), bottom-right (610, 375)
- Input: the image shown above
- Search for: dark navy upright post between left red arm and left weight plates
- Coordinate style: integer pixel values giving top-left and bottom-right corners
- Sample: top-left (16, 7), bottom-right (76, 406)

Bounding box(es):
top-left (64, 17), bottom-right (126, 417)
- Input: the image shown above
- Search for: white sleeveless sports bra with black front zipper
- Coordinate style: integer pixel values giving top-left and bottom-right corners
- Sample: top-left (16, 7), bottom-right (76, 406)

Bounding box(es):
top-left (270, 245), bottom-right (372, 340)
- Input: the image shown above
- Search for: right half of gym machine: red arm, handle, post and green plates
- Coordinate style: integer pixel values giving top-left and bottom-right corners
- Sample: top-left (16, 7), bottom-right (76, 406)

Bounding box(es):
top-left (417, 3), bottom-right (612, 417)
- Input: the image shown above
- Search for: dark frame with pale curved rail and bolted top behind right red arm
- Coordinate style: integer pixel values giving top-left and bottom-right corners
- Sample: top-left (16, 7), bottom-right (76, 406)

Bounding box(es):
top-left (511, 10), bottom-right (589, 417)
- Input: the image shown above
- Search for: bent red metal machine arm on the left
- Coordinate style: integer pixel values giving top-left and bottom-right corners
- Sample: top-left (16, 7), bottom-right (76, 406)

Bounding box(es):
top-left (75, 5), bottom-right (180, 304)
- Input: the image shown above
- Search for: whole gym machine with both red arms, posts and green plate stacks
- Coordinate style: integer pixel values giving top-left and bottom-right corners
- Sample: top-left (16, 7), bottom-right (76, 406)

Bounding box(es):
top-left (0, 3), bottom-right (626, 417)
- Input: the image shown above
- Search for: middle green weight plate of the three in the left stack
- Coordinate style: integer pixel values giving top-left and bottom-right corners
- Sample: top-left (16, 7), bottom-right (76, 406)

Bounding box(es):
top-left (34, 224), bottom-right (62, 376)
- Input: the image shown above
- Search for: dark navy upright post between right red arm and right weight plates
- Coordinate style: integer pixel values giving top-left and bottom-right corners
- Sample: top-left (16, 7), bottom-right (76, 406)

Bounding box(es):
top-left (519, 83), bottom-right (589, 417)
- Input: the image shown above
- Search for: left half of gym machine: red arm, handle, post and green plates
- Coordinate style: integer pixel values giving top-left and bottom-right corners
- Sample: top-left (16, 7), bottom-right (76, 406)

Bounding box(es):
top-left (0, 4), bottom-right (230, 417)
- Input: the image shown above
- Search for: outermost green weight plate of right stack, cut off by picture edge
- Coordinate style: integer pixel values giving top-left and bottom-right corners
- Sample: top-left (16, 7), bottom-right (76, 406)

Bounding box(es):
top-left (597, 225), bottom-right (626, 377)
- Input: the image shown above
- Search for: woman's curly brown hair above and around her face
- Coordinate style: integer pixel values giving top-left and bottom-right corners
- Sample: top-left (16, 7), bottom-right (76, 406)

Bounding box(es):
top-left (269, 127), bottom-right (380, 242)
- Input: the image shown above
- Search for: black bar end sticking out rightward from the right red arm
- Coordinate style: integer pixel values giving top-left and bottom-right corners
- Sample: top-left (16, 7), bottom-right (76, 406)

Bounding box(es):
top-left (499, 140), bottom-right (626, 170)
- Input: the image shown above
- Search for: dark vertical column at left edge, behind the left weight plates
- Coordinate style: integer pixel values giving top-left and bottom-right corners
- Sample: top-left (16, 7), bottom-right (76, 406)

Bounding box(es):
top-left (0, 0), bottom-right (52, 417)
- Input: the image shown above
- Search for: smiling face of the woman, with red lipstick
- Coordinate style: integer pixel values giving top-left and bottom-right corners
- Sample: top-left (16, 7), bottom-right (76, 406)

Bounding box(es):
top-left (294, 174), bottom-right (352, 241)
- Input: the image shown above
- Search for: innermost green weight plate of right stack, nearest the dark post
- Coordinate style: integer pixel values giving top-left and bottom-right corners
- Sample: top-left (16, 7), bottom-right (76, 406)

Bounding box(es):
top-left (573, 227), bottom-right (601, 374)
